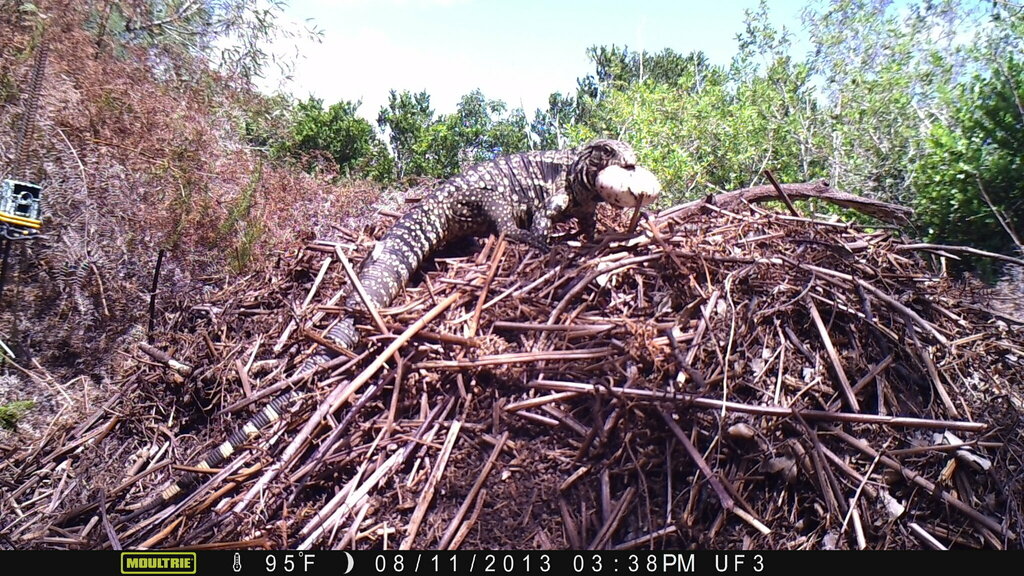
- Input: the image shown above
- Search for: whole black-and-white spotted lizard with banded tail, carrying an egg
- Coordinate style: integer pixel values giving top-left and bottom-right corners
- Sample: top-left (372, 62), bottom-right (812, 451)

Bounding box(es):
top-left (125, 139), bottom-right (660, 513)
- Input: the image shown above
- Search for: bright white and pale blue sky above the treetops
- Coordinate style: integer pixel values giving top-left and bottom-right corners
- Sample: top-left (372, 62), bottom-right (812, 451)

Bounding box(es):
top-left (262, 0), bottom-right (806, 122)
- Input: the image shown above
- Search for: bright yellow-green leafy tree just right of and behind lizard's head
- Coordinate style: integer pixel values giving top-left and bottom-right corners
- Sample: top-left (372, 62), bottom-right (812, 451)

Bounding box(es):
top-left (570, 4), bottom-right (823, 202)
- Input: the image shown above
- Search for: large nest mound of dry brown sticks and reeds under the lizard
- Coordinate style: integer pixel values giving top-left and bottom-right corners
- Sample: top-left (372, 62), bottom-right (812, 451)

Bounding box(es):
top-left (0, 184), bottom-right (1024, 549)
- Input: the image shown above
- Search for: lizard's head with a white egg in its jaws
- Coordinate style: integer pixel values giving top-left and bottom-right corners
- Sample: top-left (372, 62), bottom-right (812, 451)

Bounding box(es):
top-left (571, 139), bottom-right (662, 208)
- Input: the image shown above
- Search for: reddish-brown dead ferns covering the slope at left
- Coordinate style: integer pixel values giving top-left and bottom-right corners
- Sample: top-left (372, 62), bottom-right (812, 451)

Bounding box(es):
top-left (0, 0), bottom-right (378, 434)
